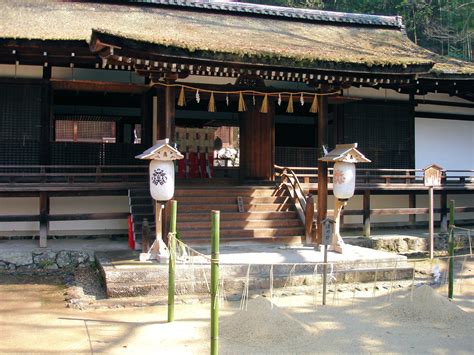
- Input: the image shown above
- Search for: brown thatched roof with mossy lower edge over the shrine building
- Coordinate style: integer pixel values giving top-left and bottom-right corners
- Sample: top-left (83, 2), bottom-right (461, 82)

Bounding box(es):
top-left (0, 0), bottom-right (474, 73)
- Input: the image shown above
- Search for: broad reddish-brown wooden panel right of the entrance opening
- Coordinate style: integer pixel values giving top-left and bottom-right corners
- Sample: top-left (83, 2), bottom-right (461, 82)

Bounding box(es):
top-left (239, 98), bottom-right (275, 180)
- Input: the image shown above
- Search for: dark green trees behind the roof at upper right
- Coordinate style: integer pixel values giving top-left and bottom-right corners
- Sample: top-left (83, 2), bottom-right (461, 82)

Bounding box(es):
top-left (248, 0), bottom-right (474, 61)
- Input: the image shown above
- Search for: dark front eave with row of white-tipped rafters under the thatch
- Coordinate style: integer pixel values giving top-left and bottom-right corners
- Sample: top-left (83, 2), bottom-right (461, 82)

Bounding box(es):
top-left (90, 31), bottom-right (432, 84)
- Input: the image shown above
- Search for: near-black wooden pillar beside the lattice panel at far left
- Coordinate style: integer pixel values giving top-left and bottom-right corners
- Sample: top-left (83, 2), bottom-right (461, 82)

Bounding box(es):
top-left (39, 66), bottom-right (52, 165)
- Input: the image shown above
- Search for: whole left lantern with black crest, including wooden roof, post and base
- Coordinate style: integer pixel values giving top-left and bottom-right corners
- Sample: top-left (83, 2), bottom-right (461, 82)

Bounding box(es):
top-left (135, 139), bottom-right (184, 261)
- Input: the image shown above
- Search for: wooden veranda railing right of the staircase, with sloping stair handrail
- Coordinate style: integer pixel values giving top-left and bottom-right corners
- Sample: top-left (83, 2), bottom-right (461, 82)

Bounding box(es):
top-left (275, 165), bottom-right (474, 236)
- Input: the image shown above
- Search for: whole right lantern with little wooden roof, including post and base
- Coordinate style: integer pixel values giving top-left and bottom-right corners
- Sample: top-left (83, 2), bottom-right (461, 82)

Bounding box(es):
top-left (318, 143), bottom-right (370, 253)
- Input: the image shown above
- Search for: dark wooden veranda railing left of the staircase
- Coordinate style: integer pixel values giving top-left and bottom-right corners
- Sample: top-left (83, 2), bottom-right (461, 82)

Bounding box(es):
top-left (0, 165), bottom-right (148, 247)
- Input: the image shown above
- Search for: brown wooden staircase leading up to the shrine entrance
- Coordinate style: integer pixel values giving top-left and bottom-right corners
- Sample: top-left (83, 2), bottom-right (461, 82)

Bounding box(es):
top-left (129, 186), bottom-right (304, 249)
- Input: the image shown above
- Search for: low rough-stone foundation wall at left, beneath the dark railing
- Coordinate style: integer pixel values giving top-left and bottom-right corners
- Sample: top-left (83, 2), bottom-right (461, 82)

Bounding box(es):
top-left (0, 249), bottom-right (93, 271)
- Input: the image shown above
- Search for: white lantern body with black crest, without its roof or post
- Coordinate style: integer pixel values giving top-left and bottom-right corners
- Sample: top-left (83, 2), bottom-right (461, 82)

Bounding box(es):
top-left (149, 160), bottom-right (174, 201)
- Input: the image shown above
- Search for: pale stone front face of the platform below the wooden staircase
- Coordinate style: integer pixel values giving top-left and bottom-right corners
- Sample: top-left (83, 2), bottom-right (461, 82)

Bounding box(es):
top-left (96, 252), bottom-right (413, 297)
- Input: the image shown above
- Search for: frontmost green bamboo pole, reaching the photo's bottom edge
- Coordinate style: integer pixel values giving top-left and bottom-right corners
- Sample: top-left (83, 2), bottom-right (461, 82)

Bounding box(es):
top-left (211, 211), bottom-right (220, 355)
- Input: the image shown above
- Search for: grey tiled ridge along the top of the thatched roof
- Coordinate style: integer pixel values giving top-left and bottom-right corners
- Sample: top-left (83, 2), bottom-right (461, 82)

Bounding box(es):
top-left (104, 0), bottom-right (404, 30)
